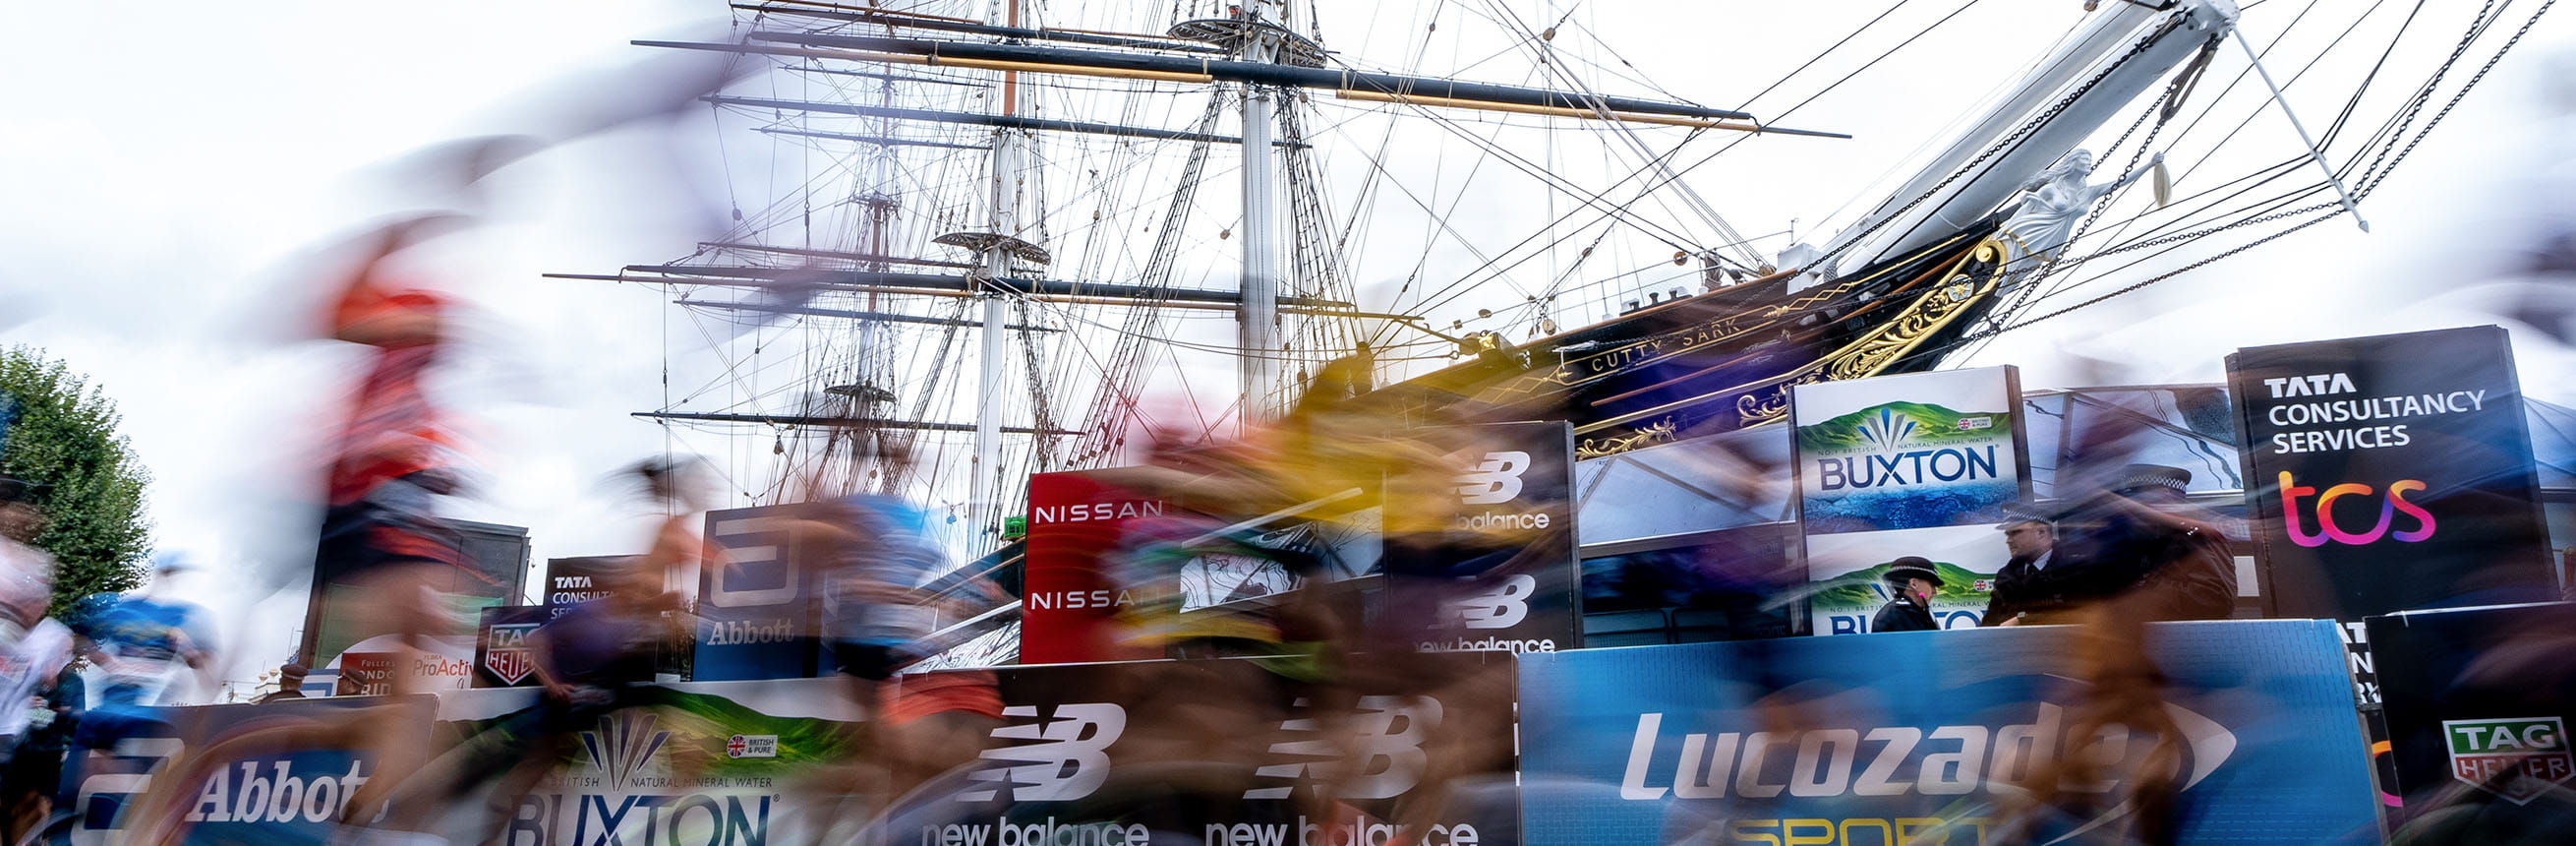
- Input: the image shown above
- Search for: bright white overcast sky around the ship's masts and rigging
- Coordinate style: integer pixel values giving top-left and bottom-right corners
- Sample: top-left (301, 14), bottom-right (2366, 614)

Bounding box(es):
top-left (0, 0), bottom-right (2576, 695)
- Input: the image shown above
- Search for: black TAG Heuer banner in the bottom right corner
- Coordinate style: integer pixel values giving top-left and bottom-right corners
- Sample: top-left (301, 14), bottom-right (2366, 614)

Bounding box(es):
top-left (2370, 604), bottom-right (2576, 843)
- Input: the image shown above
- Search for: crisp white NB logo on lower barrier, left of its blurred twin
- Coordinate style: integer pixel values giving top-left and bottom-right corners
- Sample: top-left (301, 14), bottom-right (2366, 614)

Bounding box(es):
top-left (956, 701), bottom-right (1126, 802)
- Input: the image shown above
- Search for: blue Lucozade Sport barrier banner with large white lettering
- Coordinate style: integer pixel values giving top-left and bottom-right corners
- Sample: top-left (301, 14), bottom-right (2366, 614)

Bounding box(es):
top-left (1520, 619), bottom-right (2380, 846)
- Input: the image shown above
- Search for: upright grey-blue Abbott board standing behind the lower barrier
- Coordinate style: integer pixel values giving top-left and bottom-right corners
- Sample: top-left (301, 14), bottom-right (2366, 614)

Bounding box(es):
top-left (695, 506), bottom-right (822, 681)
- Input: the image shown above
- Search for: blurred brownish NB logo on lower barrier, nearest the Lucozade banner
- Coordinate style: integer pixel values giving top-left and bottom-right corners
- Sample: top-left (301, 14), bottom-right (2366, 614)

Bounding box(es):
top-left (1244, 696), bottom-right (1440, 800)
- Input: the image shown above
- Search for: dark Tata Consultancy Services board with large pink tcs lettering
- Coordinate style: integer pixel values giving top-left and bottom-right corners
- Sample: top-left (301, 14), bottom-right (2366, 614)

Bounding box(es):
top-left (2228, 325), bottom-right (2552, 619)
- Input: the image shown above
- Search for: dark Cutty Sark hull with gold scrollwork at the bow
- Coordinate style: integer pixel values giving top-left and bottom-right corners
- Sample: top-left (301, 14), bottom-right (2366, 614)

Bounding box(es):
top-left (1363, 221), bottom-right (2004, 456)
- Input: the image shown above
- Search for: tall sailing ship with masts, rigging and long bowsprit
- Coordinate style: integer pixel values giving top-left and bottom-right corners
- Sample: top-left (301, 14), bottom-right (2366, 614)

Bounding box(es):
top-left (561, 0), bottom-right (2535, 587)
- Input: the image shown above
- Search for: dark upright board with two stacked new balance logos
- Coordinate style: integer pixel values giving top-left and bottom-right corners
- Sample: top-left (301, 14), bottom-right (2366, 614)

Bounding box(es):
top-left (1386, 420), bottom-right (1584, 652)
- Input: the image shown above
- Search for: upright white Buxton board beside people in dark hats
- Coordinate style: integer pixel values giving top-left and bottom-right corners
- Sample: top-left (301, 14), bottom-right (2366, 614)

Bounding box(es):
top-left (1790, 366), bottom-right (2030, 634)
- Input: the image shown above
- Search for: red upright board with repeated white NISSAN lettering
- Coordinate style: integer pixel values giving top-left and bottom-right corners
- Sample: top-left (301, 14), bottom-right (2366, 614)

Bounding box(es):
top-left (1021, 469), bottom-right (1167, 663)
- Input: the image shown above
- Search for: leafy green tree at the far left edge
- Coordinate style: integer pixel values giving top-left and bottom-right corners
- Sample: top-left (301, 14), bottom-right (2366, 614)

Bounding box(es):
top-left (0, 345), bottom-right (152, 614)
